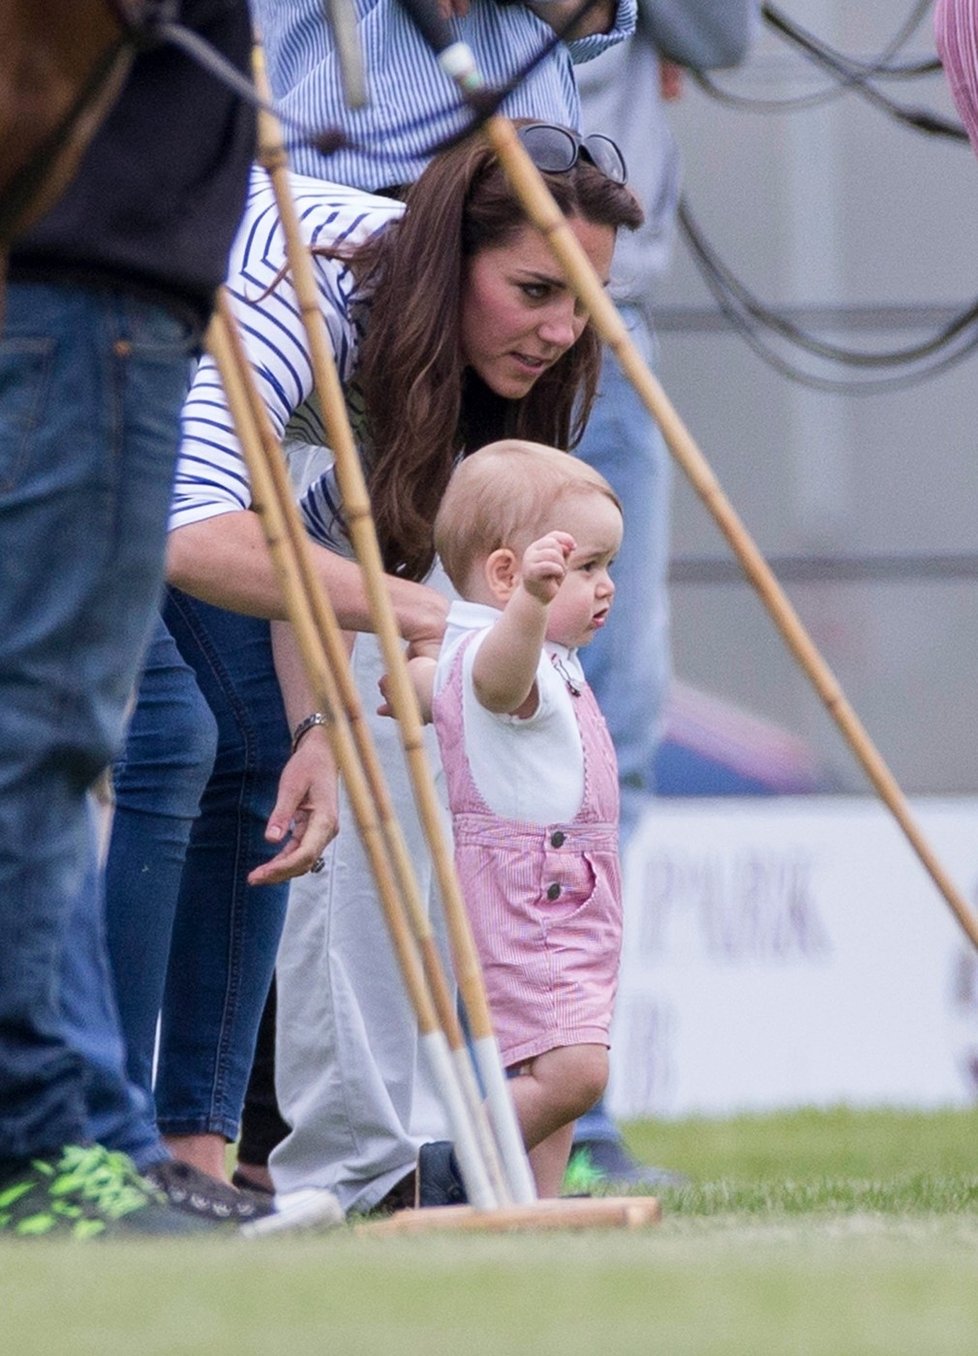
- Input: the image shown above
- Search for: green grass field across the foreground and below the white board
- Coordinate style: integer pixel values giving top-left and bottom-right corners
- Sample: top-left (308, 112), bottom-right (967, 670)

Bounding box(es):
top-left (0, 1111), bottom-right (978, 1356)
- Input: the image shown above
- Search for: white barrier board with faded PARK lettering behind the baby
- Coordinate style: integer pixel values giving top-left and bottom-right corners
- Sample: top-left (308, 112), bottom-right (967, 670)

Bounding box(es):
top-left (609, 796), bottom-right (978, 1117)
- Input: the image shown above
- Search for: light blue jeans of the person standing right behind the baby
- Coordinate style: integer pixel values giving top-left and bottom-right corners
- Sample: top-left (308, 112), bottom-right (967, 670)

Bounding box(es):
top-left (574, 306), bottom-right (671, 1140)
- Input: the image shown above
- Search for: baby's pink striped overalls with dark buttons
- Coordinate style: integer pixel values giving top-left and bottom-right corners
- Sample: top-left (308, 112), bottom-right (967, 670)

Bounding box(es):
top-left (434, 640), bottom-right (621, 1067)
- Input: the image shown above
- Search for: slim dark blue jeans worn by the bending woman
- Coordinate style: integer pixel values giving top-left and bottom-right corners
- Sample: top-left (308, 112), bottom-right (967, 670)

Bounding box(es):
top-left (107, 589), bottom-right (289, 1139)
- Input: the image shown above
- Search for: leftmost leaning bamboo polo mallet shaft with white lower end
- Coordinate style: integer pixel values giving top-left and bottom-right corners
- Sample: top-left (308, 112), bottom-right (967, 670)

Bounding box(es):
top-left (208, 293), bottom-right (498, 1210)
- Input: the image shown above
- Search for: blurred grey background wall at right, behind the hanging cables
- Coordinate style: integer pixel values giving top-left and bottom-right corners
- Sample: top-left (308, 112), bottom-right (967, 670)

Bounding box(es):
top-left (648, 0), bottom-right (978, 793)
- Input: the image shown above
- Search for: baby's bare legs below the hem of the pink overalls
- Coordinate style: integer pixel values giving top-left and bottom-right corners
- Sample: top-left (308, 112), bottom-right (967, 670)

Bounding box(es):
top-left (510, 1045), bottom-right (608, 1196)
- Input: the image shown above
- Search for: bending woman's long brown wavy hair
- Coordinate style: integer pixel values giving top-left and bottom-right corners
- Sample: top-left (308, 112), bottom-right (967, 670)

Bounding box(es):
top-left (339, 123), bottom-right (642, 579)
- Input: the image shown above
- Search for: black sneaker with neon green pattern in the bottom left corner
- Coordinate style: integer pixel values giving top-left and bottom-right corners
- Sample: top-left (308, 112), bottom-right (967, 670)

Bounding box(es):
top-left (0, 1144), bottom-right (209, 1239)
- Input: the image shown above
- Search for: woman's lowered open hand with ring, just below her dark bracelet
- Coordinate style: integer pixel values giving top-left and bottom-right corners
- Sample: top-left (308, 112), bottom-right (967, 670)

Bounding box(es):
top-left (248, 727), bottom-right (339, 885)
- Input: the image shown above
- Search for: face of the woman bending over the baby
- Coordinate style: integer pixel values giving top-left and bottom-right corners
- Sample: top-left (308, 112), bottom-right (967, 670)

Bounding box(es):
top-left (461, 217), bottom-right (614, 400)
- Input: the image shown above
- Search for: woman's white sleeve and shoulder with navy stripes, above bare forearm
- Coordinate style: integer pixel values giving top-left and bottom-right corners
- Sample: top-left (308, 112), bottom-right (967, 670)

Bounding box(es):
top-left (170, 171), bottom-right (403, 530)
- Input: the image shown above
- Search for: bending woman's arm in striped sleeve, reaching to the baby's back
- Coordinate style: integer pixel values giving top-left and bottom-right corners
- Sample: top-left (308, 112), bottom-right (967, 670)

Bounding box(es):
top-left (168, 174), bottom-right (431, 623)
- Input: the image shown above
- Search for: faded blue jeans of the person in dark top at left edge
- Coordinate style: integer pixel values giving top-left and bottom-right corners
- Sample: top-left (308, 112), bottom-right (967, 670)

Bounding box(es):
top-left (0, 283), bottom-right (191, 1162)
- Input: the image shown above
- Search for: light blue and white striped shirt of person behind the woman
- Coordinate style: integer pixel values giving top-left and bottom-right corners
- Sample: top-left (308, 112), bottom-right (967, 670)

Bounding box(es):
top-left (251, 0), bottom-right (636, 190)
